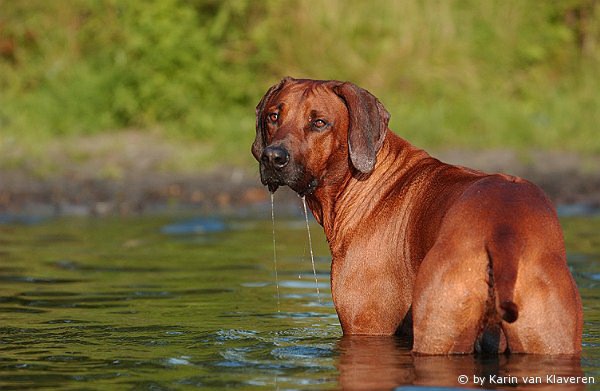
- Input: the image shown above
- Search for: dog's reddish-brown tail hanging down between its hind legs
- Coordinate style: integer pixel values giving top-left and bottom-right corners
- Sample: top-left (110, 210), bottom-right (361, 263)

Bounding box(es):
top-left (486, 230), bottom-right (519, 323)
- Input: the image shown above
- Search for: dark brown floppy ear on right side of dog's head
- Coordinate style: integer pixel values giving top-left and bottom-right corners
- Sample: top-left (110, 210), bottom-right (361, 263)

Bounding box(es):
top-left (333, 83), bottom-right (390, 174)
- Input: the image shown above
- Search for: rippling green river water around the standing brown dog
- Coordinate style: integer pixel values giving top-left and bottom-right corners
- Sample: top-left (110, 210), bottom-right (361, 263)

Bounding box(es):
top-left (0, 212), bottom-right (600, 390)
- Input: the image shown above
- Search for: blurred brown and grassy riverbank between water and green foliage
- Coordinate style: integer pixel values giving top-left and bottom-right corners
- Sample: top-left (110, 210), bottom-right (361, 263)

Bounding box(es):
top-left (0, 131), bottom-right (600, 216)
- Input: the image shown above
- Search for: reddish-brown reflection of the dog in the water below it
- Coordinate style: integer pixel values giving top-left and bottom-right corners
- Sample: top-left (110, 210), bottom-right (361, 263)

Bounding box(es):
top-left (337, 336), bottom-right (585, 390)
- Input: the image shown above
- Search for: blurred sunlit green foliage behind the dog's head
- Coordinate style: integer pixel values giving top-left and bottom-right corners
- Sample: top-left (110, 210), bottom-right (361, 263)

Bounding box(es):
top-left (0, 0), bottom-right (600, 160)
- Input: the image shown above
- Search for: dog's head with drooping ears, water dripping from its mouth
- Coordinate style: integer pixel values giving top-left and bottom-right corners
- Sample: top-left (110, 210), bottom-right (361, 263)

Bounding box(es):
top-left (252, 77), bottom-right (390, 195)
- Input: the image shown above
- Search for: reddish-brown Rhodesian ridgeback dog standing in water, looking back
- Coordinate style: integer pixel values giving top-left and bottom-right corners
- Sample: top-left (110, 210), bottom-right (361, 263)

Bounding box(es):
top-left (252, 77), bottom-right (583, 354)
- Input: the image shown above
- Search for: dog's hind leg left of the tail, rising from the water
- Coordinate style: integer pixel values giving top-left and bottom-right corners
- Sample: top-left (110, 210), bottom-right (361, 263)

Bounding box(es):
top-left (413, 240), bottom-right (489, 354)
